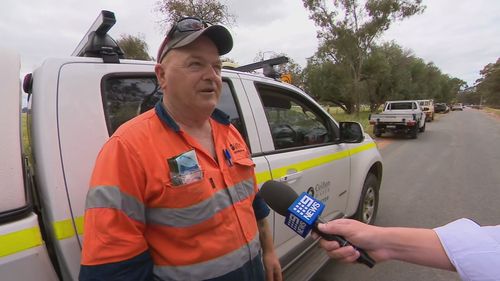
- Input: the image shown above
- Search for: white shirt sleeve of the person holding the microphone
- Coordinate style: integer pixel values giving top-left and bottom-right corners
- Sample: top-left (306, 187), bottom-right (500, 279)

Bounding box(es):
top-left (434, 219), bottom-right (500, 281)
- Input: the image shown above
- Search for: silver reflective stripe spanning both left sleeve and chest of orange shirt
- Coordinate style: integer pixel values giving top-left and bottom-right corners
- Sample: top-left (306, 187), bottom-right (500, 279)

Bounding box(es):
top-left (85, 178), bottom-right (254, 227)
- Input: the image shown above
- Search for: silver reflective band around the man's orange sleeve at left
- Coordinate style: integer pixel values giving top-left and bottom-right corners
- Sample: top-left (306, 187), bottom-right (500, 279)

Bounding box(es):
top-left (85, 185), bottom-right (146, 223)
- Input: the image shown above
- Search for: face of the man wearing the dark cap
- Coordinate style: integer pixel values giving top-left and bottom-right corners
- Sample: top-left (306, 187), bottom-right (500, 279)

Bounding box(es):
top-left (155, 36), bottom-right (222, 114)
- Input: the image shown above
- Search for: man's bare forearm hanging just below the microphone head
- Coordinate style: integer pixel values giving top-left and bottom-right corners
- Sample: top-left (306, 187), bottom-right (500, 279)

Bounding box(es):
top-left (257, 218), bottom-right (282, 281)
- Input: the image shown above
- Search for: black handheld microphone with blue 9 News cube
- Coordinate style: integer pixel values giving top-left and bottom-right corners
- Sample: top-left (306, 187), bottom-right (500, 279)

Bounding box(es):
top-left (259, 180), bottom-right (375, 268)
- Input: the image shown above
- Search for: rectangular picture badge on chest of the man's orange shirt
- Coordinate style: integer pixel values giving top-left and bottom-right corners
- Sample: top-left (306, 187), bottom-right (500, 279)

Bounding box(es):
top-left (167, 149), bottom-right (203, 186)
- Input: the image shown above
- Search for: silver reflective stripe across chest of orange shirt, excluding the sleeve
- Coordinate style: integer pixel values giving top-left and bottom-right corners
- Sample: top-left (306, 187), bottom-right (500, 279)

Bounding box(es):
top-left (146, 178), bottom-right (254, 227)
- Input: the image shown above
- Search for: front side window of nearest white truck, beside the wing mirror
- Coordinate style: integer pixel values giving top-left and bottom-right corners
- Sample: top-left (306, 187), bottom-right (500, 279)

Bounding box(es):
top-left (258, 86), bottom-right (334, 149)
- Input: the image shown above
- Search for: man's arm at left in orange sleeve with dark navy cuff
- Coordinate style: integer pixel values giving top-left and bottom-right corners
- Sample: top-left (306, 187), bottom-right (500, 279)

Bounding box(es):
top-left (79, 137), bottom-right (153, 281)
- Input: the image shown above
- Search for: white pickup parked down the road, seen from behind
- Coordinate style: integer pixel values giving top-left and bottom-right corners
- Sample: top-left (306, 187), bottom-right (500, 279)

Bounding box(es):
top-left (368, 100), bottom-right (426, 139)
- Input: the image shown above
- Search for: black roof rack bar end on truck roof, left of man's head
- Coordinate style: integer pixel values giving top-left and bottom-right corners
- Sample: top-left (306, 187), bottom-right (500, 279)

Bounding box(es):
top-left (71, 10), bottom-right (123, 63)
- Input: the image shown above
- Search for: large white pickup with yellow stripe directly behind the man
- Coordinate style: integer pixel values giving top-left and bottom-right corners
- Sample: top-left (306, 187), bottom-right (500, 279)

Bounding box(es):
top-left (0, 11), bottom-right (382, 281)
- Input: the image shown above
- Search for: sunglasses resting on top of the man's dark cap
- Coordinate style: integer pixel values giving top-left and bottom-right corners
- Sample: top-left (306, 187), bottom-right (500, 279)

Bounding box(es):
top-left (158, 17), bottom-right (211, 62)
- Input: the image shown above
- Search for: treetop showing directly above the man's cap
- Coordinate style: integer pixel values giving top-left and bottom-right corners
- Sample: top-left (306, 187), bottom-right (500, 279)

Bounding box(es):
top-left (156, 0), bottom-right (236, 30)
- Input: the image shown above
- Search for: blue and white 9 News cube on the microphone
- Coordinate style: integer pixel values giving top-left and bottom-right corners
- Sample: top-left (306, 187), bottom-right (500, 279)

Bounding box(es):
top-left (285, 192), bottom-right (325, 235)
